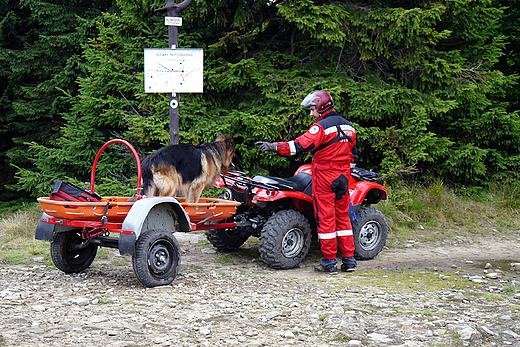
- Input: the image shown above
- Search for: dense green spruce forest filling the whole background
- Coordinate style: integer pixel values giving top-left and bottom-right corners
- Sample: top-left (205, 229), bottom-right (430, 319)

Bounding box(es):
top-left (0, 0), bottom-right (520, 201)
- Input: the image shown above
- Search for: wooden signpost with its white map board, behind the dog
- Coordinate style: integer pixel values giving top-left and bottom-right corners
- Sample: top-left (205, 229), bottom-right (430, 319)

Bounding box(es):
top-left (153, 0), bottom-right (196, 145)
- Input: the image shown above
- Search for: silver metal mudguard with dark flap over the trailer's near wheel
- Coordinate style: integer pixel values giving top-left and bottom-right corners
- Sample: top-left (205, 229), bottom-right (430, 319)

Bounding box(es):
top-left (118, 197), bottom-right (191, 255)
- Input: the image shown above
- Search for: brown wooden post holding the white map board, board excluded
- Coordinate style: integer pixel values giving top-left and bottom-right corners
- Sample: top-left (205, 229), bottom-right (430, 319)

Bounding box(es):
top-left (155, 0), bottom-right (195, 145)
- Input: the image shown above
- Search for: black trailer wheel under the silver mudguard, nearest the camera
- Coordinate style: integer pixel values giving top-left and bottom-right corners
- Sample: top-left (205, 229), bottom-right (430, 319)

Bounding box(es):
top-left (132, 230), bottom-right (181, 287)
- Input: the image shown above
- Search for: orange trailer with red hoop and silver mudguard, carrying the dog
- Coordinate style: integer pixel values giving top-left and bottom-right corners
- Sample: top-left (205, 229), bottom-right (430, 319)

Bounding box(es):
top-left (35, 139), bottom-right (241, 287)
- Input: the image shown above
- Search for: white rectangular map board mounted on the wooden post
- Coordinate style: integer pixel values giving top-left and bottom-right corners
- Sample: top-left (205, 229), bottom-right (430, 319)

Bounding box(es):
top-left (144, 48), bottom-right (204, 93)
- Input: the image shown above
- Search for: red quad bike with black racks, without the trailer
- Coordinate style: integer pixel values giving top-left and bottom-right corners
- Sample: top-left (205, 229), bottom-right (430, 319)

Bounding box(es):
top-left (205, 164), bottom-right (388, 269)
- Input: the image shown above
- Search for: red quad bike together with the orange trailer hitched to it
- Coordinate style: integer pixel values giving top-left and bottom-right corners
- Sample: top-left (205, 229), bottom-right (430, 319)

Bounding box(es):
top-left (35, 139), bottom-right (388, 287)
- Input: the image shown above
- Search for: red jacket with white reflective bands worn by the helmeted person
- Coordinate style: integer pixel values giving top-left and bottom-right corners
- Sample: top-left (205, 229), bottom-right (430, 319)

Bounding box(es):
top-left (277, 110), bottom-right (358, 169)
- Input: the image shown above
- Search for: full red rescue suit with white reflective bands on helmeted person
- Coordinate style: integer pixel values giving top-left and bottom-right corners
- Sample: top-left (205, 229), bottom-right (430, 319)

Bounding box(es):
top-left (277, 110), bottom-right (358, 259)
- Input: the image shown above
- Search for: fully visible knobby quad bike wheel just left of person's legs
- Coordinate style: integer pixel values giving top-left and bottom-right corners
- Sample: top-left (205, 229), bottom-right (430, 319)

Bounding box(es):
top-left (258, 210), bottom-right (312, 269)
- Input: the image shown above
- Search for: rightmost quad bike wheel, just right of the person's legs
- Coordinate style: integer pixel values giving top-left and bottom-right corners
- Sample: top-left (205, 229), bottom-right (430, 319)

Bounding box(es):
top-left (352, 207), bottom-right (388, 260)
